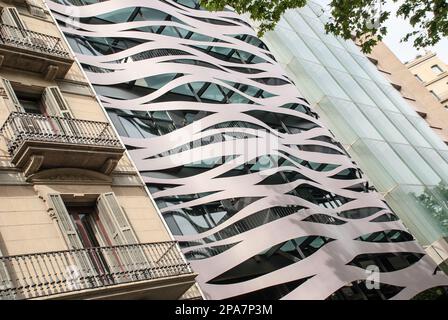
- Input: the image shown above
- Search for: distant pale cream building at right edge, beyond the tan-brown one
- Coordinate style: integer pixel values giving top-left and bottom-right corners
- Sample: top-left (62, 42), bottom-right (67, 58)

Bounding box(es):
top-left (406, 51), bottom-right (448, 109)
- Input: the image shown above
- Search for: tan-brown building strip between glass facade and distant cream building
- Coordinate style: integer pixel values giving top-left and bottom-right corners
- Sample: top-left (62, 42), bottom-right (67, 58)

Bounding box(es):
top-left (360, 42), bottom-right (448, 143)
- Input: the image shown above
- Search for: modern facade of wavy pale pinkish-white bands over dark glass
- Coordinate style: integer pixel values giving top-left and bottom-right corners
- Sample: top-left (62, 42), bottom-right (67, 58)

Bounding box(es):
top-left (48, 0), bottom-right (448, 299)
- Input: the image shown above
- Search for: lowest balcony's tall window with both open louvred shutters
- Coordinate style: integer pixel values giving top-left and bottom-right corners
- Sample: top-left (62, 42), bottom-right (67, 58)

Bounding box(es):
top-left (48, 192), bottom-right (149, 284)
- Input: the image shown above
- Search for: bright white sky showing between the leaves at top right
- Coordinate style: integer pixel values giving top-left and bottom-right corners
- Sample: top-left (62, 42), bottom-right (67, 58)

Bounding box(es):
top-left (314, 0), bottom-right (448, 64)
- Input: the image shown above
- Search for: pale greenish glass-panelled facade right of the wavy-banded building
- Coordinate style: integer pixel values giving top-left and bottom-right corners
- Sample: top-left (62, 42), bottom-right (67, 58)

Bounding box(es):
top-left (265, 2), bottom-right (448, 268)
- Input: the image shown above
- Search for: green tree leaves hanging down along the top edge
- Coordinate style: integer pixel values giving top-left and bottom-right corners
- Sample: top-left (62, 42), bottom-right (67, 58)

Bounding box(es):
top-left (200, 0), bottom-right (448, 53)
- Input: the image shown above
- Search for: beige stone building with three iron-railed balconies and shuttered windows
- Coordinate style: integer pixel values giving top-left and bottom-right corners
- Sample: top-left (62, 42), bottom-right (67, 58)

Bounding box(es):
top-left (0, 0), bottom-right (196, 300)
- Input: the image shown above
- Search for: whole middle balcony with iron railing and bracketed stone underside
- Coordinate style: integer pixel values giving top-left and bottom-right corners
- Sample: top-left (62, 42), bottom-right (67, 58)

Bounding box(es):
top-left (0, 112), bottom-right (124, 177)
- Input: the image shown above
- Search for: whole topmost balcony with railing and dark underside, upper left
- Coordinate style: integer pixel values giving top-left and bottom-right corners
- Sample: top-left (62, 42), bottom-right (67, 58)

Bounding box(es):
top-left (0, 23), bottom-right (74, 81)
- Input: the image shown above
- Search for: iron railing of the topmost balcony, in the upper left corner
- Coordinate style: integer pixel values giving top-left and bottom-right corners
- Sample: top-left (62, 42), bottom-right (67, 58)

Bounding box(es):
top-left (0, 23), bottom-right (70, 58)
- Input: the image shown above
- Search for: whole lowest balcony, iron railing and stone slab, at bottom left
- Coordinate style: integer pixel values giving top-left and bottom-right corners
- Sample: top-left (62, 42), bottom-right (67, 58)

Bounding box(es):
top-left (0, 241), bottom-right (196, 300)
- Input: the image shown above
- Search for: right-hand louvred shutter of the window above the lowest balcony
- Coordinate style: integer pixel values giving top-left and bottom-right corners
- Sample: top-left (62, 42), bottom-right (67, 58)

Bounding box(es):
top-left (97, 192), bottom-right (150, 271)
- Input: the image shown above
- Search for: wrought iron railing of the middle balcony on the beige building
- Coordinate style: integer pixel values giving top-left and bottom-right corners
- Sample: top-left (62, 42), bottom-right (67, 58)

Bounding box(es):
top-left (0, 112), bottom-right (121, 156)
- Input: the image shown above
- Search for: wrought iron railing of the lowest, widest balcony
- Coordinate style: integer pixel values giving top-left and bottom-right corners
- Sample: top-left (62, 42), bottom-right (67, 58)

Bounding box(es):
top-left (0, 241), bottom-right (194, 300)
